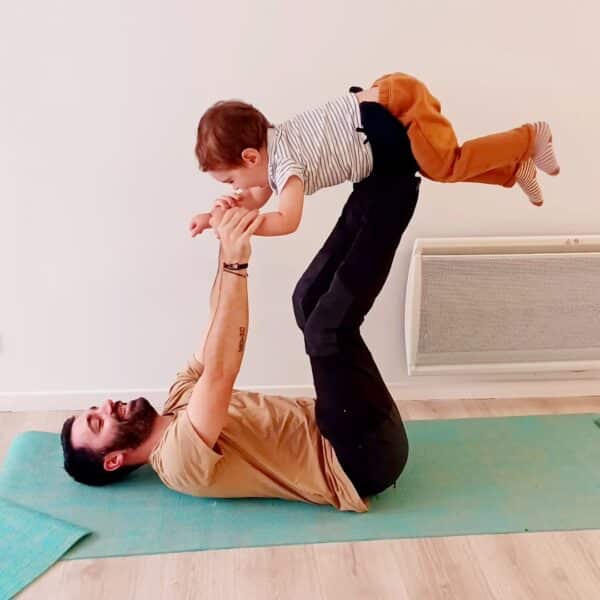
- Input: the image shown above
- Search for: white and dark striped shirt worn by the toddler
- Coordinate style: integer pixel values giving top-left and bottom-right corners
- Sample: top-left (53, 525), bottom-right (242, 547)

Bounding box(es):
top-left (267, 93), bottom-right (373, 195)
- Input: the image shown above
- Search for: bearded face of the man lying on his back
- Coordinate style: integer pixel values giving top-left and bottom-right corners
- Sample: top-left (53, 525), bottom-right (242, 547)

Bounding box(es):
top-left (71, 398), bottom-right (158, 452)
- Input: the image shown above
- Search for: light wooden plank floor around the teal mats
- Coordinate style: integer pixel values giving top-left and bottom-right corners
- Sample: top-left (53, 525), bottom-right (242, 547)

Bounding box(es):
top-left (0, 396), bottom-right (600, 600)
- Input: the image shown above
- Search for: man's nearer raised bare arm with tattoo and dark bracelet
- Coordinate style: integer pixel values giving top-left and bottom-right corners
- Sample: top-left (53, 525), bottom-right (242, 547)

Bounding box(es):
top-left (187, 208), bottom-right (261, 448)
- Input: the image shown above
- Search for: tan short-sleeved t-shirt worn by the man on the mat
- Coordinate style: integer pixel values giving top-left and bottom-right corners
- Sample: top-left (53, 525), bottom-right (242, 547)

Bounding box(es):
top-left (150, 357), bottom-right (368, 512)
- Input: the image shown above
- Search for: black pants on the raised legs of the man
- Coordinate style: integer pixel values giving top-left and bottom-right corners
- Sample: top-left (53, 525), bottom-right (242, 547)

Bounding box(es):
top-left (293, 97), bottom-right (420, 497)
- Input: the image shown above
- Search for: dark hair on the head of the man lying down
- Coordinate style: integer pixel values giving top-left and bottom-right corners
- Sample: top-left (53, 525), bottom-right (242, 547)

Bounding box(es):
top-left (60, 417), bottom-right (142, 485)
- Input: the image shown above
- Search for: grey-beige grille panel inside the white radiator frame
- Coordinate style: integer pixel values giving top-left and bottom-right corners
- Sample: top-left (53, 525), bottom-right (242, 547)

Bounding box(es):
top-left (407, 238), bottom-right (600, 372)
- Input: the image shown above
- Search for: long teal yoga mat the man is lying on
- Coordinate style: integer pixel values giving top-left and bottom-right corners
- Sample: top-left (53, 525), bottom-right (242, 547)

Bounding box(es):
top-left (0, 414), bottom-right (600, 558)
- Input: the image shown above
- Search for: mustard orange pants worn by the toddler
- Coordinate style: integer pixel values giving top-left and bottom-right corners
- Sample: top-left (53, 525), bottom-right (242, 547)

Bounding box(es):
top-left (373, 73), bottom-right (535, 187)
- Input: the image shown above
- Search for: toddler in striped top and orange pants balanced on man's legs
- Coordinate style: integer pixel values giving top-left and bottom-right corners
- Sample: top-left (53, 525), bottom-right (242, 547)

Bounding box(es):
top-left (189, 73), bottom-right (560, 236)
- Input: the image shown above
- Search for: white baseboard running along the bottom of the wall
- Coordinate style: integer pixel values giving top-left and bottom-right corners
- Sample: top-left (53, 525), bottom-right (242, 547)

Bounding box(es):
top-left (0, 378), bottom-right (600, 412)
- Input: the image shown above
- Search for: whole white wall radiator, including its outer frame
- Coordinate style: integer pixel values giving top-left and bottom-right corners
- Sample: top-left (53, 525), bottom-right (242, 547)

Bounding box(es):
top-left (405, 235), bottom-right (600, 375)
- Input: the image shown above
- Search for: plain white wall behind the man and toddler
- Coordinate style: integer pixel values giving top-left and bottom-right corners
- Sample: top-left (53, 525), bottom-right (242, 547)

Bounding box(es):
top-left (0, 0), bottom-right (600, 407)
